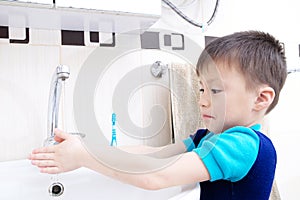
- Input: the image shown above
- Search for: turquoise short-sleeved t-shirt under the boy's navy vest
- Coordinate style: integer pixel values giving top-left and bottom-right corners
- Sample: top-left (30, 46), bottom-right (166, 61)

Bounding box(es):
top-left (183, 124), bottom-right (261, 182)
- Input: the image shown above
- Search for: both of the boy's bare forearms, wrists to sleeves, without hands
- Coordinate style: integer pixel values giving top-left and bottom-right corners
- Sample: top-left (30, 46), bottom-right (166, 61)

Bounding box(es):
top-left (84, 147), bottom-right (209, 190)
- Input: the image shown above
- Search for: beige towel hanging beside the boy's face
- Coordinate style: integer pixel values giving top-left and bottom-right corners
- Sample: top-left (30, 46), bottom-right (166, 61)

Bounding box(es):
top-left (169, 63), bottom-right (202, 141)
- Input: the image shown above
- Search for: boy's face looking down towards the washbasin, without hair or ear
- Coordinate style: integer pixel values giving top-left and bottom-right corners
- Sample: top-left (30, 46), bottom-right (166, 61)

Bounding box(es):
top-left (199, 64), bottom-right (256, 133)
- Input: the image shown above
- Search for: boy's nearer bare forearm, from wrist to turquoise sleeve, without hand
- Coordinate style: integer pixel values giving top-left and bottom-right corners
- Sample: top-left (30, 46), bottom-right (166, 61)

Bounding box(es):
top-left (85, 149), bottom-right (210, 190)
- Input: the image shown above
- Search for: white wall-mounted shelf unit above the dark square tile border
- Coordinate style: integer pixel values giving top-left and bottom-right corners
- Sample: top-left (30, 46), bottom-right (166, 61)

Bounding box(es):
top-left (0, 0), bottom-right (161, 33)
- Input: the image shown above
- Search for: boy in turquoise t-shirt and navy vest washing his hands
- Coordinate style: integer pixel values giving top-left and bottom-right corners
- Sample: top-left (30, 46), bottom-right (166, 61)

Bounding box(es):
top-left (29, 31), bottom-right (287, 200)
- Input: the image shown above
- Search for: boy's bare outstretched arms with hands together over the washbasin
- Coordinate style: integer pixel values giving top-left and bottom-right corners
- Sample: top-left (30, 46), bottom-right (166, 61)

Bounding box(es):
top-left (29, 132), bottom-right (210, 190)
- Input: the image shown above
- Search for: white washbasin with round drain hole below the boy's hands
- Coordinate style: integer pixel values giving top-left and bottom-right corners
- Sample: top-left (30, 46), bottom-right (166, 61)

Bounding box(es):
top-left (0, 160), bottom-right (199, 200)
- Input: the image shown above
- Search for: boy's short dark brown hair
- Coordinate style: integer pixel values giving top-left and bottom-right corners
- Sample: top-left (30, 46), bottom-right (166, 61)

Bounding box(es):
top-left (197, 31), bottom-right (287, 113)
